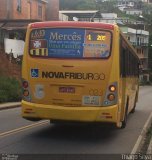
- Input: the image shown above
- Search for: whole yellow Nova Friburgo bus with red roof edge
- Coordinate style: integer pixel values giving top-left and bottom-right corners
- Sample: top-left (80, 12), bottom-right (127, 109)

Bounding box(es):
top-left (22, 22), bottom-right (139, 128)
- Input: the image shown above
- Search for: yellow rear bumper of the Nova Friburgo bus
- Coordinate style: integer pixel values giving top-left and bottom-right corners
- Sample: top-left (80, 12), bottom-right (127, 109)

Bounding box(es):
top-left (22, 101), bottom-right (119, 123)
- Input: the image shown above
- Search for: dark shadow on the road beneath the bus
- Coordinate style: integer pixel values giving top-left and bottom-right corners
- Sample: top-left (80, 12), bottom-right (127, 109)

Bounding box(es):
top-left (29, 124), bottom-right (117, 142)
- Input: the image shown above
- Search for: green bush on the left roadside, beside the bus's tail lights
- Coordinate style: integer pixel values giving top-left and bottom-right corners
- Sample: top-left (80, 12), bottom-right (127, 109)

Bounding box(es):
top-left (0, 77), bottom-right (21, 103)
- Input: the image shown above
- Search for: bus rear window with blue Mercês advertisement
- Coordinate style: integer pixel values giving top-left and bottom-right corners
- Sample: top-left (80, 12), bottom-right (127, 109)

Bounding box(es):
top-left (29, 28), bottom-right (112, 58)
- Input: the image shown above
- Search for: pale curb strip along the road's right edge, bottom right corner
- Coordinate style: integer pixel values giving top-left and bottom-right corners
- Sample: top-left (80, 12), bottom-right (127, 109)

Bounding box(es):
top-left (131, 113), bottom-right (152, 154)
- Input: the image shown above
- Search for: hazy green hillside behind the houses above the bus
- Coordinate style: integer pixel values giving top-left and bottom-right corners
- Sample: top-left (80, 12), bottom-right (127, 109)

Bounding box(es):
top-left (60, 0), bottom-right (152, 23)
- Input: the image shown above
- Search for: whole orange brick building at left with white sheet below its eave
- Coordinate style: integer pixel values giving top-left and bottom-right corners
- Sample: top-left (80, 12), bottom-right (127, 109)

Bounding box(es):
top-left (0, 0), bottom-right (59, 57)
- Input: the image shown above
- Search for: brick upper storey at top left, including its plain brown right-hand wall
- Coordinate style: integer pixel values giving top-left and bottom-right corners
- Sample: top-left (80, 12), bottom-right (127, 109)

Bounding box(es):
top-left (0, 0), bottom-right (59, 21)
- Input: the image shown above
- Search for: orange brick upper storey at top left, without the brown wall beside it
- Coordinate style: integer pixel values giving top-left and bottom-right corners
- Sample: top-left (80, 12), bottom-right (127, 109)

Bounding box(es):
top-left (0, 0), bottom-right (47, 21)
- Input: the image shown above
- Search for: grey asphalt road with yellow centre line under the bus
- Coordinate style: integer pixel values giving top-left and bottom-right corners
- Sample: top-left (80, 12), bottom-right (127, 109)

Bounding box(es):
top-left (0, 86), bottom-right (152, 154)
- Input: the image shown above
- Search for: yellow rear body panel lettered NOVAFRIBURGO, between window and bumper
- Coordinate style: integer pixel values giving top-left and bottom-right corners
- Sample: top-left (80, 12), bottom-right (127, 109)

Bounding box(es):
top-left (25, 59), bottom-right (111, 105)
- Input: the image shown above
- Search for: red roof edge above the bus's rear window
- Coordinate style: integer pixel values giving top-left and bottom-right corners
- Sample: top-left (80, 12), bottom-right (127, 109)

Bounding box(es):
top-left (30, 21), bottom-right (115, 30)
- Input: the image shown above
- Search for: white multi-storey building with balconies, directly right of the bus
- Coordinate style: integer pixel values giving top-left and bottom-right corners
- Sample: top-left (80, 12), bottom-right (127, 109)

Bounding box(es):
top-left (121, 27), bottom-right (149, 81)
